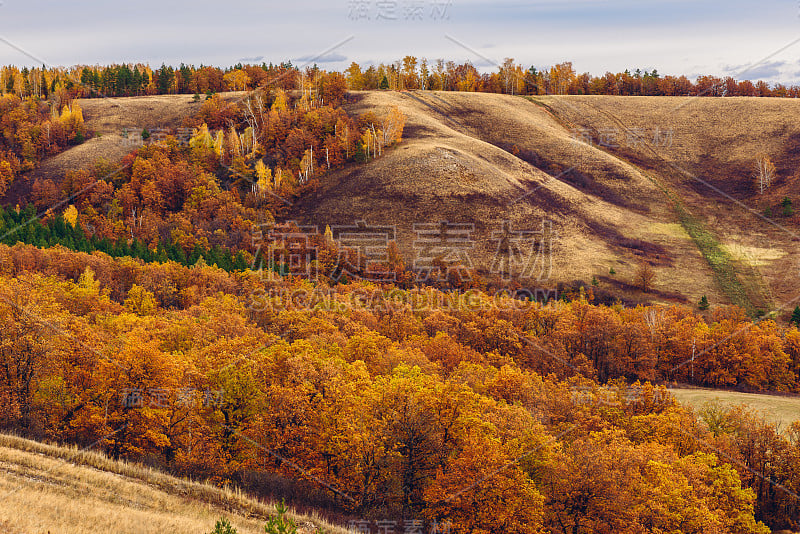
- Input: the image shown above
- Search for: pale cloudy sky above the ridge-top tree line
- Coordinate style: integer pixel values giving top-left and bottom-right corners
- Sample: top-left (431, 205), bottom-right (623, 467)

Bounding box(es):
top-left (0, 0), bottom-right (800, 83)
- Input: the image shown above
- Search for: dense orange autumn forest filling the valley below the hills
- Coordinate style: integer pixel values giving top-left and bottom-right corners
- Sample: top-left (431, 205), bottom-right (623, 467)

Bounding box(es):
top-left (0, 244), bottom-right (800, 534)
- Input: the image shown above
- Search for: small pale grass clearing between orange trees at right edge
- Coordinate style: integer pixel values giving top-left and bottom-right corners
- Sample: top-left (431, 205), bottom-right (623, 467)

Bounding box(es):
top-left (669, 388), bottom-right (800, 430)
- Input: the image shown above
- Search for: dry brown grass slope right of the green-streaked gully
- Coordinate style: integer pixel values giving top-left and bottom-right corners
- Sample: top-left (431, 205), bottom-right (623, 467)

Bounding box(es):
top-left (540, 96), bottom-right (800, 316)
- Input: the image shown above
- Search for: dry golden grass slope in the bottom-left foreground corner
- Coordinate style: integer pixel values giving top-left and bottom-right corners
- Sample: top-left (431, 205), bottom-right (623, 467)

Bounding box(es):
top-left (0, 434), bottom-right (346, 534)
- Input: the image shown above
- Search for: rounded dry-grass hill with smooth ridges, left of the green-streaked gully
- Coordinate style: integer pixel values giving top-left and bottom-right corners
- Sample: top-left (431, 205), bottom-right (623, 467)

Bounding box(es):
top-left (290, 91), bottom-right (724, 302)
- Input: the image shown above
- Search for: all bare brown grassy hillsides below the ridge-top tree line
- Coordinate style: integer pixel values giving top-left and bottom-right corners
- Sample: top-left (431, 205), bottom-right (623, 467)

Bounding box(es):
top-left (7, 91), bottom-right (800, 317)
